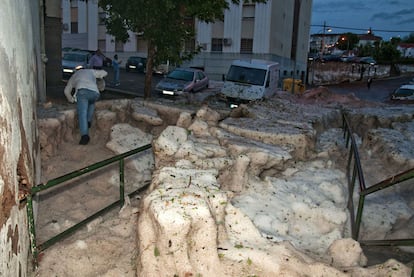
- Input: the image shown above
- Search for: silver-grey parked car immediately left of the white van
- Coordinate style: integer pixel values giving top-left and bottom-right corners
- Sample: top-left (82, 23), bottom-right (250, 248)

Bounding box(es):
top-left (155, 68), bottom-right (209, 95)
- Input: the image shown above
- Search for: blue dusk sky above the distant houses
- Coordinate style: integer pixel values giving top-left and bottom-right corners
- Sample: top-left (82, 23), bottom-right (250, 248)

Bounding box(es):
top-left (311, 0), bottom-right (414, 40)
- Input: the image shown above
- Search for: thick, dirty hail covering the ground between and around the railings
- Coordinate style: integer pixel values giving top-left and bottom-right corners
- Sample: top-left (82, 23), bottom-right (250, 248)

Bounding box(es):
top-left (35, 85), bottom-right (414, 276)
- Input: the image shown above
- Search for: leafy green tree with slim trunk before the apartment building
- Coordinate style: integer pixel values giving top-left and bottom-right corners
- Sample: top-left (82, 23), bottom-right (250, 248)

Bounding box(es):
top-left (99, 0), bottom-right (267, 98)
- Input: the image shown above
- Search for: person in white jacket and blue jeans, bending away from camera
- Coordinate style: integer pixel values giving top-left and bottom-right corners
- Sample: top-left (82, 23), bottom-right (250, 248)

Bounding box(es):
top-left (64, 69), bottom-right (108, 145)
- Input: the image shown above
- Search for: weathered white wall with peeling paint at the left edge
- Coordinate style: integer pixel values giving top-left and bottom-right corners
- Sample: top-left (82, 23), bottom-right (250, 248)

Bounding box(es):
top-left (0, 0), bottom-right (42, 276)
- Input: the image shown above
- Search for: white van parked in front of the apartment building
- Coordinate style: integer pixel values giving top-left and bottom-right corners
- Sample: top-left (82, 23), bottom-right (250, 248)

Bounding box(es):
top-left (221, 59), bottom-right (279, 101)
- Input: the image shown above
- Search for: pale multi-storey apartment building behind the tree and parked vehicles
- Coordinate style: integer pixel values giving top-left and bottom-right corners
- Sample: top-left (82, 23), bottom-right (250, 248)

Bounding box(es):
top-left (62, 0), bottom-right (312, 80)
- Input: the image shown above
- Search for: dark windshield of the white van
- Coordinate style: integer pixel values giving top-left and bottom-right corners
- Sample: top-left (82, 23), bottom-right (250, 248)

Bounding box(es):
top-left (226, 65), bottom-right (266, 86)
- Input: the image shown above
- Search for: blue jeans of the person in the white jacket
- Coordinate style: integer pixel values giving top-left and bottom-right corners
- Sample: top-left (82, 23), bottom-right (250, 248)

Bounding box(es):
top-left (76, 88), bottom-right (100, 136)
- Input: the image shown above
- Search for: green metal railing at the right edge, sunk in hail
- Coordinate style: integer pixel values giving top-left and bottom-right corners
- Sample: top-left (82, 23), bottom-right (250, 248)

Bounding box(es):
top-left (342, 112), bottom-right (414, 246)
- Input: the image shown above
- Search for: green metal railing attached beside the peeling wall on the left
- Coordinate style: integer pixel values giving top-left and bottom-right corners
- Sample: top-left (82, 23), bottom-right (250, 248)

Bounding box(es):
top-left (26, 144), bottom-right (152, 266)
